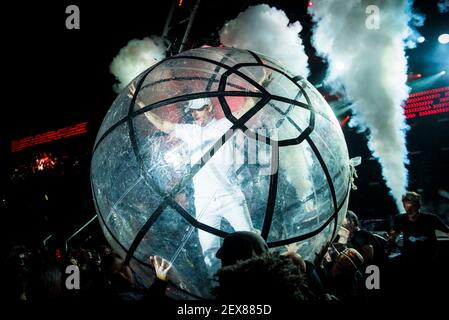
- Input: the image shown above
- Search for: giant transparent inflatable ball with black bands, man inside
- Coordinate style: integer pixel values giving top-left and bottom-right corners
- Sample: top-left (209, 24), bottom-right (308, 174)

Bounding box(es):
top-left (91, 48), bottom-right (351, 299)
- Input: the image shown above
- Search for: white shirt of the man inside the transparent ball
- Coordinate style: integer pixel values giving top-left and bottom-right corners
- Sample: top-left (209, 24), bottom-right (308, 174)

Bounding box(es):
top-left (173, 118), bottom-right (242, 197)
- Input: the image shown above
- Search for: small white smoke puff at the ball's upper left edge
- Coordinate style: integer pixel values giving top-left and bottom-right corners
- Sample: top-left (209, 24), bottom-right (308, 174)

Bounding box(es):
top-left (109, 36), bottom-right (167, 92)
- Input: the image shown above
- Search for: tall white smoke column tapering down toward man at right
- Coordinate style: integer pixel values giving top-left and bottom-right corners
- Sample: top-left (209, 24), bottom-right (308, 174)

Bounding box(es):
top-left (309, 0), bottom-right (411, 209)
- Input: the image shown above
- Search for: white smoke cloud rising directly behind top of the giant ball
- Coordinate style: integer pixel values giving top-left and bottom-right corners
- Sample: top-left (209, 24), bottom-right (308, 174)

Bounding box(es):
top-left (220, 4), bottom-right (309, 78)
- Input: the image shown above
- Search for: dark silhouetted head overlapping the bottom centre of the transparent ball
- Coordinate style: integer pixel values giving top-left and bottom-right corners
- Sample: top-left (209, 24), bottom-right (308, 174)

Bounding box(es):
top-left (216, 231), bottom-right (268, 267)
